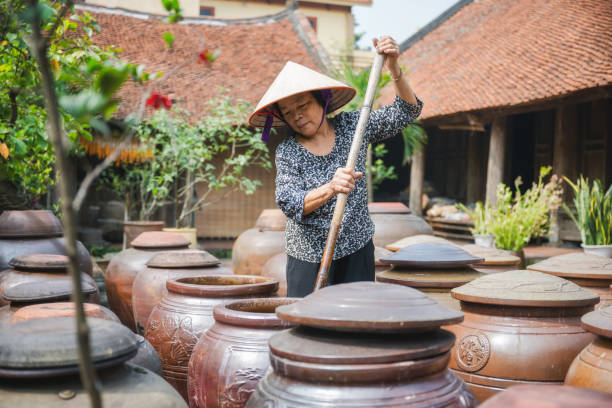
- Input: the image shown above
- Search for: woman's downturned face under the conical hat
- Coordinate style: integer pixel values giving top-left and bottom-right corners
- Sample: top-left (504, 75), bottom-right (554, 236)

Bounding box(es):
top-left (278, 92), bottom-right (323, 138)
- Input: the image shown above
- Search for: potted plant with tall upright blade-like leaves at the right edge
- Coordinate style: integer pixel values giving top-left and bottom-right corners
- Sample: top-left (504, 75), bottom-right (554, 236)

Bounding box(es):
top-left (563, 176), bottom-right (612, 258)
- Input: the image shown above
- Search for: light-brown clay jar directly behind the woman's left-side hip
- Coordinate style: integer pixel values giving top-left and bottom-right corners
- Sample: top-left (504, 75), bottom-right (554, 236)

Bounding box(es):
top-left (232, 209), bottom-right (287, 275)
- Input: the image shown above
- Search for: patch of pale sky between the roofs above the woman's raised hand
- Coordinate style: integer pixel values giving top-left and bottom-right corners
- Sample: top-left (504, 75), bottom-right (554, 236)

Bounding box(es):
top-left (353, 0), bottom-right (457, 47)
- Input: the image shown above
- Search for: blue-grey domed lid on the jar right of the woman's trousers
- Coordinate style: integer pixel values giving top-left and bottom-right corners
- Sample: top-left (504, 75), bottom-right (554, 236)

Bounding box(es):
top-left (380, 242), bottom-right (484, 268)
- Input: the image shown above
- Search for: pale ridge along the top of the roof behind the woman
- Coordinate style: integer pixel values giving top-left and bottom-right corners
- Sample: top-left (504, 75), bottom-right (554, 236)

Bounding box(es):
top-left (74, 4), bottom-right (291, 26)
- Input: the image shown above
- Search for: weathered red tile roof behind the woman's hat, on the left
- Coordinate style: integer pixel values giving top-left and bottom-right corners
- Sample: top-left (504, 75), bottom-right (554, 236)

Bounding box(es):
top-left (77, 5), bottom-right (328, 116)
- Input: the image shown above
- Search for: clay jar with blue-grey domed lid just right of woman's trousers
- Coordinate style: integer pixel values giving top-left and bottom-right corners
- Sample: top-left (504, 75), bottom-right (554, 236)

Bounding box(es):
top-left (376, 241), bottom-right (484, 310)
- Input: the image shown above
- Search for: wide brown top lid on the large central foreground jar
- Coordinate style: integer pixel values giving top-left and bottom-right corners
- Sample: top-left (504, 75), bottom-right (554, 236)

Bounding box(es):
top-left (276, 282), bottom-right (463, 332)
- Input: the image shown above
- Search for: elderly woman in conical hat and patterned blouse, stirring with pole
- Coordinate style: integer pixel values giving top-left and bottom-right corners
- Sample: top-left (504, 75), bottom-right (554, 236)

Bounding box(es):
top-left (249, 37), bottom-right (422, 297)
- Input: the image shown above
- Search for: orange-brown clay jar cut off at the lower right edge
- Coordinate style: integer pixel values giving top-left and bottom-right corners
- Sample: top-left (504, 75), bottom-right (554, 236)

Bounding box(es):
top-left (565, 305), bottom-right (612, 394)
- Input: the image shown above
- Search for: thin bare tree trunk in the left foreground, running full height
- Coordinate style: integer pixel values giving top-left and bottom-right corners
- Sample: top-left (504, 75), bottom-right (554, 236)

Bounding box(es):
top-left (29, 0), bottom-right (102, 408)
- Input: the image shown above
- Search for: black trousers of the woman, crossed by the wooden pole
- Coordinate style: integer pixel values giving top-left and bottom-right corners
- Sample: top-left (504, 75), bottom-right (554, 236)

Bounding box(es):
top-left (286, 240), bottom-right (374, 297)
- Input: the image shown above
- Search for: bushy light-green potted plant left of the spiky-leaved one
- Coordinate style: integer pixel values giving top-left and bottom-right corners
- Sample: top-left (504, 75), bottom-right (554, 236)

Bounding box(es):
top-left (489, 166), bottom-right (563, 260)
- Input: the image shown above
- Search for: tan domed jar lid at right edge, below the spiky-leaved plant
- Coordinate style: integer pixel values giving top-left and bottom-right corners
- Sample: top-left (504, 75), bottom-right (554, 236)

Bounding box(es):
top-left (527, 252), bottom-right (612, 279)
